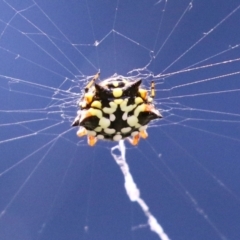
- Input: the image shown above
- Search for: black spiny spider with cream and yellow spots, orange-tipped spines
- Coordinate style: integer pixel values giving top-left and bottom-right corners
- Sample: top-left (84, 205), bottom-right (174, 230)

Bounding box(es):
top-left (72, 73), bottom-right (162, 146)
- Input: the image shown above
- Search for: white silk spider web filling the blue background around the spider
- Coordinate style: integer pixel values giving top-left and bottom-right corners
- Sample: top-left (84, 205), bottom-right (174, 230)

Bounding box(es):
top-left (0, 0), bottom-right (240, 240)
